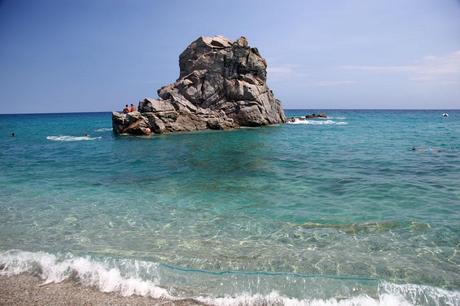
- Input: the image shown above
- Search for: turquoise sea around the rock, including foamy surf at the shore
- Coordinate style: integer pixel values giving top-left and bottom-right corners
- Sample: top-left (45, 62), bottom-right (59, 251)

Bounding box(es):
top-left (0, 110), bottom-right (460, 305)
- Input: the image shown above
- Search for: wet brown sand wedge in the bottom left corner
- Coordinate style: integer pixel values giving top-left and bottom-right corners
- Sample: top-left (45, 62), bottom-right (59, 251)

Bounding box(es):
top-left (0, 274), bottom-right (204, 306)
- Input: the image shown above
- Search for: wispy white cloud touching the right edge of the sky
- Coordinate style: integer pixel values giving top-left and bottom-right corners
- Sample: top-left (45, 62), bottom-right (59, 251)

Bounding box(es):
top-left (340, 50), bottom-right (460, 85)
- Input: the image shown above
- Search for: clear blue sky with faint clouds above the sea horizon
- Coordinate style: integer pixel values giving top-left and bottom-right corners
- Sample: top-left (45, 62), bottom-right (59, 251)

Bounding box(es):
top-left (0, 0), bottom-right (460, 113)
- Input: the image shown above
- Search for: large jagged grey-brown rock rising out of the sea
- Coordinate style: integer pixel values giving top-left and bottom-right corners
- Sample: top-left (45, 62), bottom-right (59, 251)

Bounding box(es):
top-left (112, 36), bottom-right (286, 135)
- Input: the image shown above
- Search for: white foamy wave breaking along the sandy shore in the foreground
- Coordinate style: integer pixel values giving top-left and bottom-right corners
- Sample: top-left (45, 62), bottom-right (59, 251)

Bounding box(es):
top-left (0, 250), bottom-right (460, 306)
